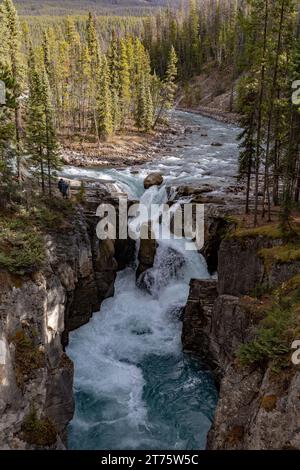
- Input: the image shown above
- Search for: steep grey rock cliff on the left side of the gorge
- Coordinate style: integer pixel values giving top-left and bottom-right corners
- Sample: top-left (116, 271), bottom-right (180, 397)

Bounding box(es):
top-left (0, 200), bottom-right (134, 449)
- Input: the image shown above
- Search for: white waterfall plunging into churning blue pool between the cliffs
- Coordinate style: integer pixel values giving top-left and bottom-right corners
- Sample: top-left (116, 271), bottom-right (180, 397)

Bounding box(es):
top-left (68, 179), bottom-right (216, 449)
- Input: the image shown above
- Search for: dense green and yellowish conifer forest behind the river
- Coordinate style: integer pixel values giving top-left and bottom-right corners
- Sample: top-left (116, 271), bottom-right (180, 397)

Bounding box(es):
top-left (0, 0), bottom-right (300, 234)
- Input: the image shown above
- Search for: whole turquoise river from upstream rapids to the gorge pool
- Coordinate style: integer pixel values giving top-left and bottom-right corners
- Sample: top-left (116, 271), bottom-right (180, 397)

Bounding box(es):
top-left (64, 112), bottom-right (239, 450)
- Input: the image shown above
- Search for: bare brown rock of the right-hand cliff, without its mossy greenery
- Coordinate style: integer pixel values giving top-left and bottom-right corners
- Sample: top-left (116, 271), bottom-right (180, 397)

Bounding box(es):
top-left (182, 229), bottom-right (300, 449)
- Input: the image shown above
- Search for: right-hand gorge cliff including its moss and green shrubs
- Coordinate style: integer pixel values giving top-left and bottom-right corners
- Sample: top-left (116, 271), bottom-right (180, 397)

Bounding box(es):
top-left (183, 218), bottom-right (300, 450)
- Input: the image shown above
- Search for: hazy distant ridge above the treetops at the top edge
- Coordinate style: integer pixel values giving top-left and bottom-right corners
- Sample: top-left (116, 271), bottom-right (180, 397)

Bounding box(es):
top-left (15, 0), bottom-right (180, 16)
